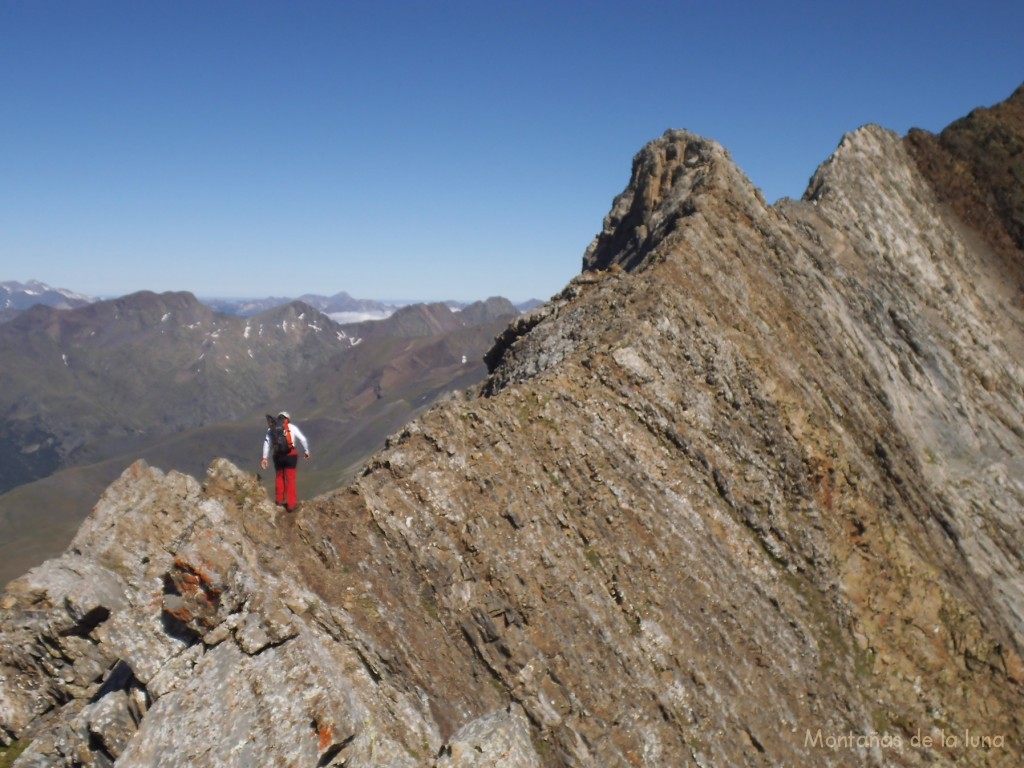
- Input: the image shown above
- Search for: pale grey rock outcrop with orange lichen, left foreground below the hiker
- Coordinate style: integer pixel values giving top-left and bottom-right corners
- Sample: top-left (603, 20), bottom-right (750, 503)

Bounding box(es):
top-left (0, 462), bottom-right (416, 766)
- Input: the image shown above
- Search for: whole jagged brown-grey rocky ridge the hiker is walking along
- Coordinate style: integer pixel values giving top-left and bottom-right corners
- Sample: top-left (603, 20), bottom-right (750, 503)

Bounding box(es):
top-left (0, 88), bottom-right (1024, 768)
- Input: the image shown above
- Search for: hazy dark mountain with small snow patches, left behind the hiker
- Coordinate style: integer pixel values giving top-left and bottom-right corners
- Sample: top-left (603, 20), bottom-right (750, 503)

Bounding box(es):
top-left (0, 292), bottom-right (357, 490)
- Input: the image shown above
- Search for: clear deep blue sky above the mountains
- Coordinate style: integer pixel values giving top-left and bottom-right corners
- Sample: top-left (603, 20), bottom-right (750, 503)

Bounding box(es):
top-left (0, 0), bottom-right (1024, 301)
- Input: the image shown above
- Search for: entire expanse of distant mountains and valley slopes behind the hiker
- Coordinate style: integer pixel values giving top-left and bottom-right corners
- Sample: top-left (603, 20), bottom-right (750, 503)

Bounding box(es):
top-left (0, 283), bottom-right (519, 584)
